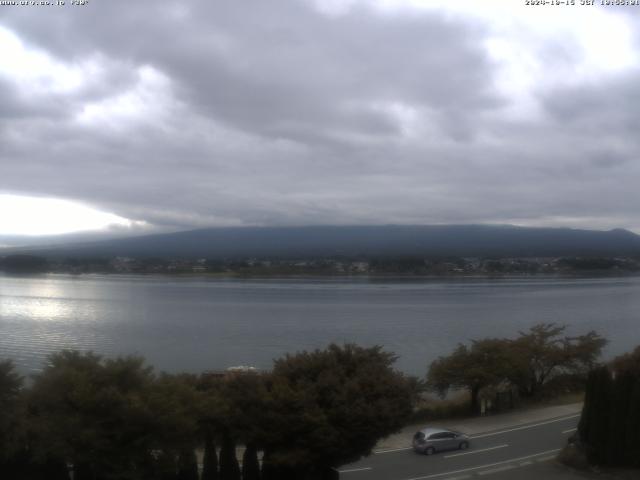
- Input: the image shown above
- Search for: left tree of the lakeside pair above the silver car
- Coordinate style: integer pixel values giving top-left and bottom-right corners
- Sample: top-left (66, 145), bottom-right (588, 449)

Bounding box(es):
top-left (427, 338), bottom-right (514, 414)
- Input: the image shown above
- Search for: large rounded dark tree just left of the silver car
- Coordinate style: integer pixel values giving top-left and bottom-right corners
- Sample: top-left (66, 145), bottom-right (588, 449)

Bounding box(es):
top-left (260, 344), bottom-right (412, 478)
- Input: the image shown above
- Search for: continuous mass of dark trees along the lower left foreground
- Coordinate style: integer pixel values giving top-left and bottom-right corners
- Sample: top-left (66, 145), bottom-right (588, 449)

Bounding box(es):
top-left (0, 344), bottom-right (414, 480)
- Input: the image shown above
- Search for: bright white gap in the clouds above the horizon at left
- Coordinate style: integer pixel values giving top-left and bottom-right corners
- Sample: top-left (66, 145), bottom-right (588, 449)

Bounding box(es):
top-left (0, 194), bottom-right (134, 235)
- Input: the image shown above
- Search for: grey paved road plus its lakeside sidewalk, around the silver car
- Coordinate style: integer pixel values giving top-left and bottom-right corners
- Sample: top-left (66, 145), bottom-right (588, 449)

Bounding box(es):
top-left (340, 404), bottom-right (581, 480)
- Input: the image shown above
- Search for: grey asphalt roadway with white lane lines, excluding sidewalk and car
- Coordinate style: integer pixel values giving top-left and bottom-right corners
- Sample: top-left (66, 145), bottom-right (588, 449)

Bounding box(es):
top-left (339, 415), bottom-right (580, 480)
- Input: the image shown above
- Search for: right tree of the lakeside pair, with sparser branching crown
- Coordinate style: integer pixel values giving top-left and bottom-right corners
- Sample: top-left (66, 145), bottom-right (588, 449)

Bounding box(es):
top-left (510, 323), bottom-right (607, 397)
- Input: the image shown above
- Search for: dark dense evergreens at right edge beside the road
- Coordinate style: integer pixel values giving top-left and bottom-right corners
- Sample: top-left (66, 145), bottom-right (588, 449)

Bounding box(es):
top-left (577, 347), bottom-right (640, 468)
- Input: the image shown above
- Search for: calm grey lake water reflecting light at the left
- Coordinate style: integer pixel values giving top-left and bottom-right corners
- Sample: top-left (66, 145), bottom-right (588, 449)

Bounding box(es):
top-left (0, 275), bottom-right (640, 375)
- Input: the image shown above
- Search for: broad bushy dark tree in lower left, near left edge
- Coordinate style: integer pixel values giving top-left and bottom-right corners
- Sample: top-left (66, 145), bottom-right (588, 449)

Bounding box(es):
top-left (30, 351), bottom-right (161, 480)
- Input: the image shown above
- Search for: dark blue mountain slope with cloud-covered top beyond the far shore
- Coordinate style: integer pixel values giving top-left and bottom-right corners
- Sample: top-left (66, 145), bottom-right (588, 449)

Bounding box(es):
top-left (7, 225), bottom-right (640, 258)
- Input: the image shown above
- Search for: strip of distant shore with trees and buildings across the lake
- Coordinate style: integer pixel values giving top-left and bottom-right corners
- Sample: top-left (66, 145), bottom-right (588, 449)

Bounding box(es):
top-left (0, 254), bottom-right (640, 276)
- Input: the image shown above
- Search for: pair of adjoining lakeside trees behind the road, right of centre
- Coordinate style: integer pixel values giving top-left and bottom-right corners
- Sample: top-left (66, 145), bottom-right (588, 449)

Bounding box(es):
top-left (427, 323), bottom-right (606, 414)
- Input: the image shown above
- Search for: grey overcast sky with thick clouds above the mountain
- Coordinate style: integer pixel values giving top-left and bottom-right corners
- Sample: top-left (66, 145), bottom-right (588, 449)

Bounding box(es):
top-left (0, 0), bottom-right (640, 233)
